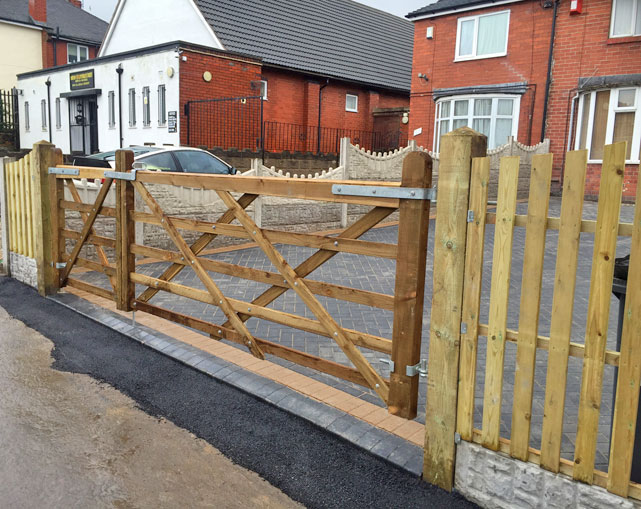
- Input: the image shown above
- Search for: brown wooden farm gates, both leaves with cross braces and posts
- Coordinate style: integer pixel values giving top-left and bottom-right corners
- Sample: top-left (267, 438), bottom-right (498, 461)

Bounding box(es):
top-left (37, 144), bottom-right (432, 419)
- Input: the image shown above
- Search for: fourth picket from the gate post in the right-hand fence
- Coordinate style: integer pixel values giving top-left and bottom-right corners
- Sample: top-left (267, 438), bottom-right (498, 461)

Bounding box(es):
top-left (541, 149), bottom-right (588, 473)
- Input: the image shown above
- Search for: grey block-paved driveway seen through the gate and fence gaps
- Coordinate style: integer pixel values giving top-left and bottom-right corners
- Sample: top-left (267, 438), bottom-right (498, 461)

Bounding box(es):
top-left (77, 198), bottom-right (634, 470)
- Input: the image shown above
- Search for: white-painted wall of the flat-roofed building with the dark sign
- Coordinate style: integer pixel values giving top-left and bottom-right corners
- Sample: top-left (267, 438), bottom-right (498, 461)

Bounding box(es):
top-left (17, 50), bottom-right (180, 154)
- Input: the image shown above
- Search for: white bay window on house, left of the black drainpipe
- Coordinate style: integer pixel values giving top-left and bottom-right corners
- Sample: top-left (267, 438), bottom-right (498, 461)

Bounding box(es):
top-left (434, 95), bottom-right (521, 152)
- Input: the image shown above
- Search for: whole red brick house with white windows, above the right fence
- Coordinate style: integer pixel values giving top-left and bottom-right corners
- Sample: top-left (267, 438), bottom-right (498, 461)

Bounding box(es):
top-left (407, 0), bottom-right (641, 196)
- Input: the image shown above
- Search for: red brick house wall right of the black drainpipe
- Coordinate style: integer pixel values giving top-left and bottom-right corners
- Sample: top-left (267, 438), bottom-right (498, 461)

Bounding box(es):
top-left (547, 0), bottom-right (641, 197)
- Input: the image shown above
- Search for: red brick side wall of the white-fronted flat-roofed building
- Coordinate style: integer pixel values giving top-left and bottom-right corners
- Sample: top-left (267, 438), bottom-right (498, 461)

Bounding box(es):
top-left (180, 50), bottom-right (261, 149)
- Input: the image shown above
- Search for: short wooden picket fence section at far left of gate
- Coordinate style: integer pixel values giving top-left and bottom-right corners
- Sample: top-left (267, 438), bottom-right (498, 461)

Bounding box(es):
top-left (3, 153), bottom-right (36, 258)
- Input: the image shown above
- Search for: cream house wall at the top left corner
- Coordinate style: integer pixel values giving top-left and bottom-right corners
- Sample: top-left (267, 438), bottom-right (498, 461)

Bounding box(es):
top-left (0, 21), bottom-right (42, 90)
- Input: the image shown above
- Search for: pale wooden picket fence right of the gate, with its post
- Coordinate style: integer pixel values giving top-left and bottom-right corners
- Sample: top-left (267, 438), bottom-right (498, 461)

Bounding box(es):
top-left (425, 132), bottom-right (641, 499)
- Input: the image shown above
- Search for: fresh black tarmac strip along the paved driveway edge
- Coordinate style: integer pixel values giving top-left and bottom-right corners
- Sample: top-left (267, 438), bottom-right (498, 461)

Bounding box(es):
top-left (0, 278), bottom-right (475, 508)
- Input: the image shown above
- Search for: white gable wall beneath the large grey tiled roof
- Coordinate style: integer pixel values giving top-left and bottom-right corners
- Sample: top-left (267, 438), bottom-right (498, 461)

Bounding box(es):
top-left (99, 0), bottom-right (224, 56)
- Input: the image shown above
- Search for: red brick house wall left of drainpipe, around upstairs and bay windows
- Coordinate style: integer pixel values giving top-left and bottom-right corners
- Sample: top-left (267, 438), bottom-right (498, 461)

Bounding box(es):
top-left (409, 0), bottom-right (552, 149)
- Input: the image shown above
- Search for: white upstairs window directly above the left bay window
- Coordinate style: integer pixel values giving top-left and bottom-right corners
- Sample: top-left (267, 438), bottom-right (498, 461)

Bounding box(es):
top-left (454, 11), bottom-right (510, 61)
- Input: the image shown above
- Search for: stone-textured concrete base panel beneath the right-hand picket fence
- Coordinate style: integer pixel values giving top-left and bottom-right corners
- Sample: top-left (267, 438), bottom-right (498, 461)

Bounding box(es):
top-left (454, 442), bottom-right (640, 509)
